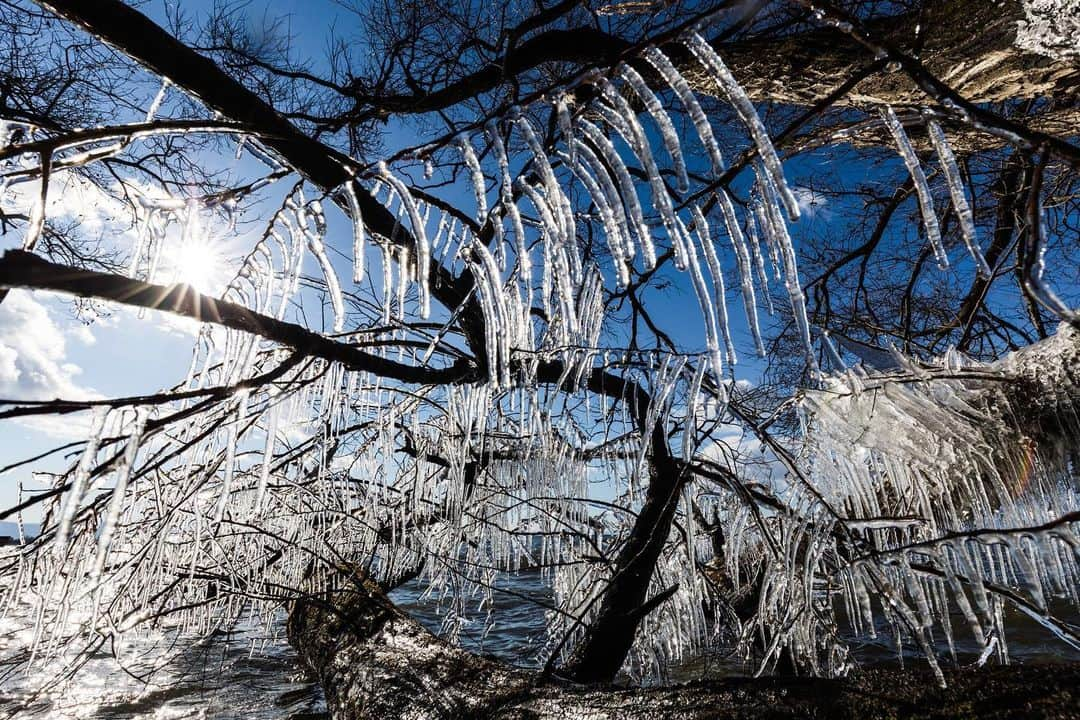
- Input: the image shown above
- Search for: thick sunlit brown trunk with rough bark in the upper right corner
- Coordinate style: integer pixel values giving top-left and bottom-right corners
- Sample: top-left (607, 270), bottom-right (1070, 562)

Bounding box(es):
top-left (695, 0), bottom-right (1080, 153)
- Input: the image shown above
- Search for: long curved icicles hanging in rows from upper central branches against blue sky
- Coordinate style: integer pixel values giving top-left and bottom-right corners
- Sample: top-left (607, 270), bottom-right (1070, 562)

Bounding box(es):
top-left (315, 32), bottom-right (814, 386)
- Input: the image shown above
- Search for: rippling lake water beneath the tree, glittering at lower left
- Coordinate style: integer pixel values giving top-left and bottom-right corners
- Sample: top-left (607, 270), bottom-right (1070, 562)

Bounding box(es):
top-left (0, 573), bottom-right (1080, 720)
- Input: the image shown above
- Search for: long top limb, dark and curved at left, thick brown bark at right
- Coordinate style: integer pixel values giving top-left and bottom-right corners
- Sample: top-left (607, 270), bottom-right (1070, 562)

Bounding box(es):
top-left (336, 0), bottom-right (1080, 114)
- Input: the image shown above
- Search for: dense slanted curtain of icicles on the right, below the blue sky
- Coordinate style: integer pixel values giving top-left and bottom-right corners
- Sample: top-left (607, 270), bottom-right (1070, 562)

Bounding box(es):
top-left (794, 324), bottom-right (1080, 678)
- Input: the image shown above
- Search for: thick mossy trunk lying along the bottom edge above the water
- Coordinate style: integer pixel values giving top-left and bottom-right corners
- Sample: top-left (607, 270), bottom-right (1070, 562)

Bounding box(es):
top-left (288, 571), bottom-right (1080, 720)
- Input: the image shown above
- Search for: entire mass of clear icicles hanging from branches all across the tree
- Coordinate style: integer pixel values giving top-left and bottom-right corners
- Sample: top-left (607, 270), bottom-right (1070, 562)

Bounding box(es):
top-left (2, 25), bottom-right (1076, 690)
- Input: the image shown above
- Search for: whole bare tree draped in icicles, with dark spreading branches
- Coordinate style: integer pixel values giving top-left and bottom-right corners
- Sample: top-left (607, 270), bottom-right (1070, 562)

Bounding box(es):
top-left (0, 0), bottom-right (1080, 718)
